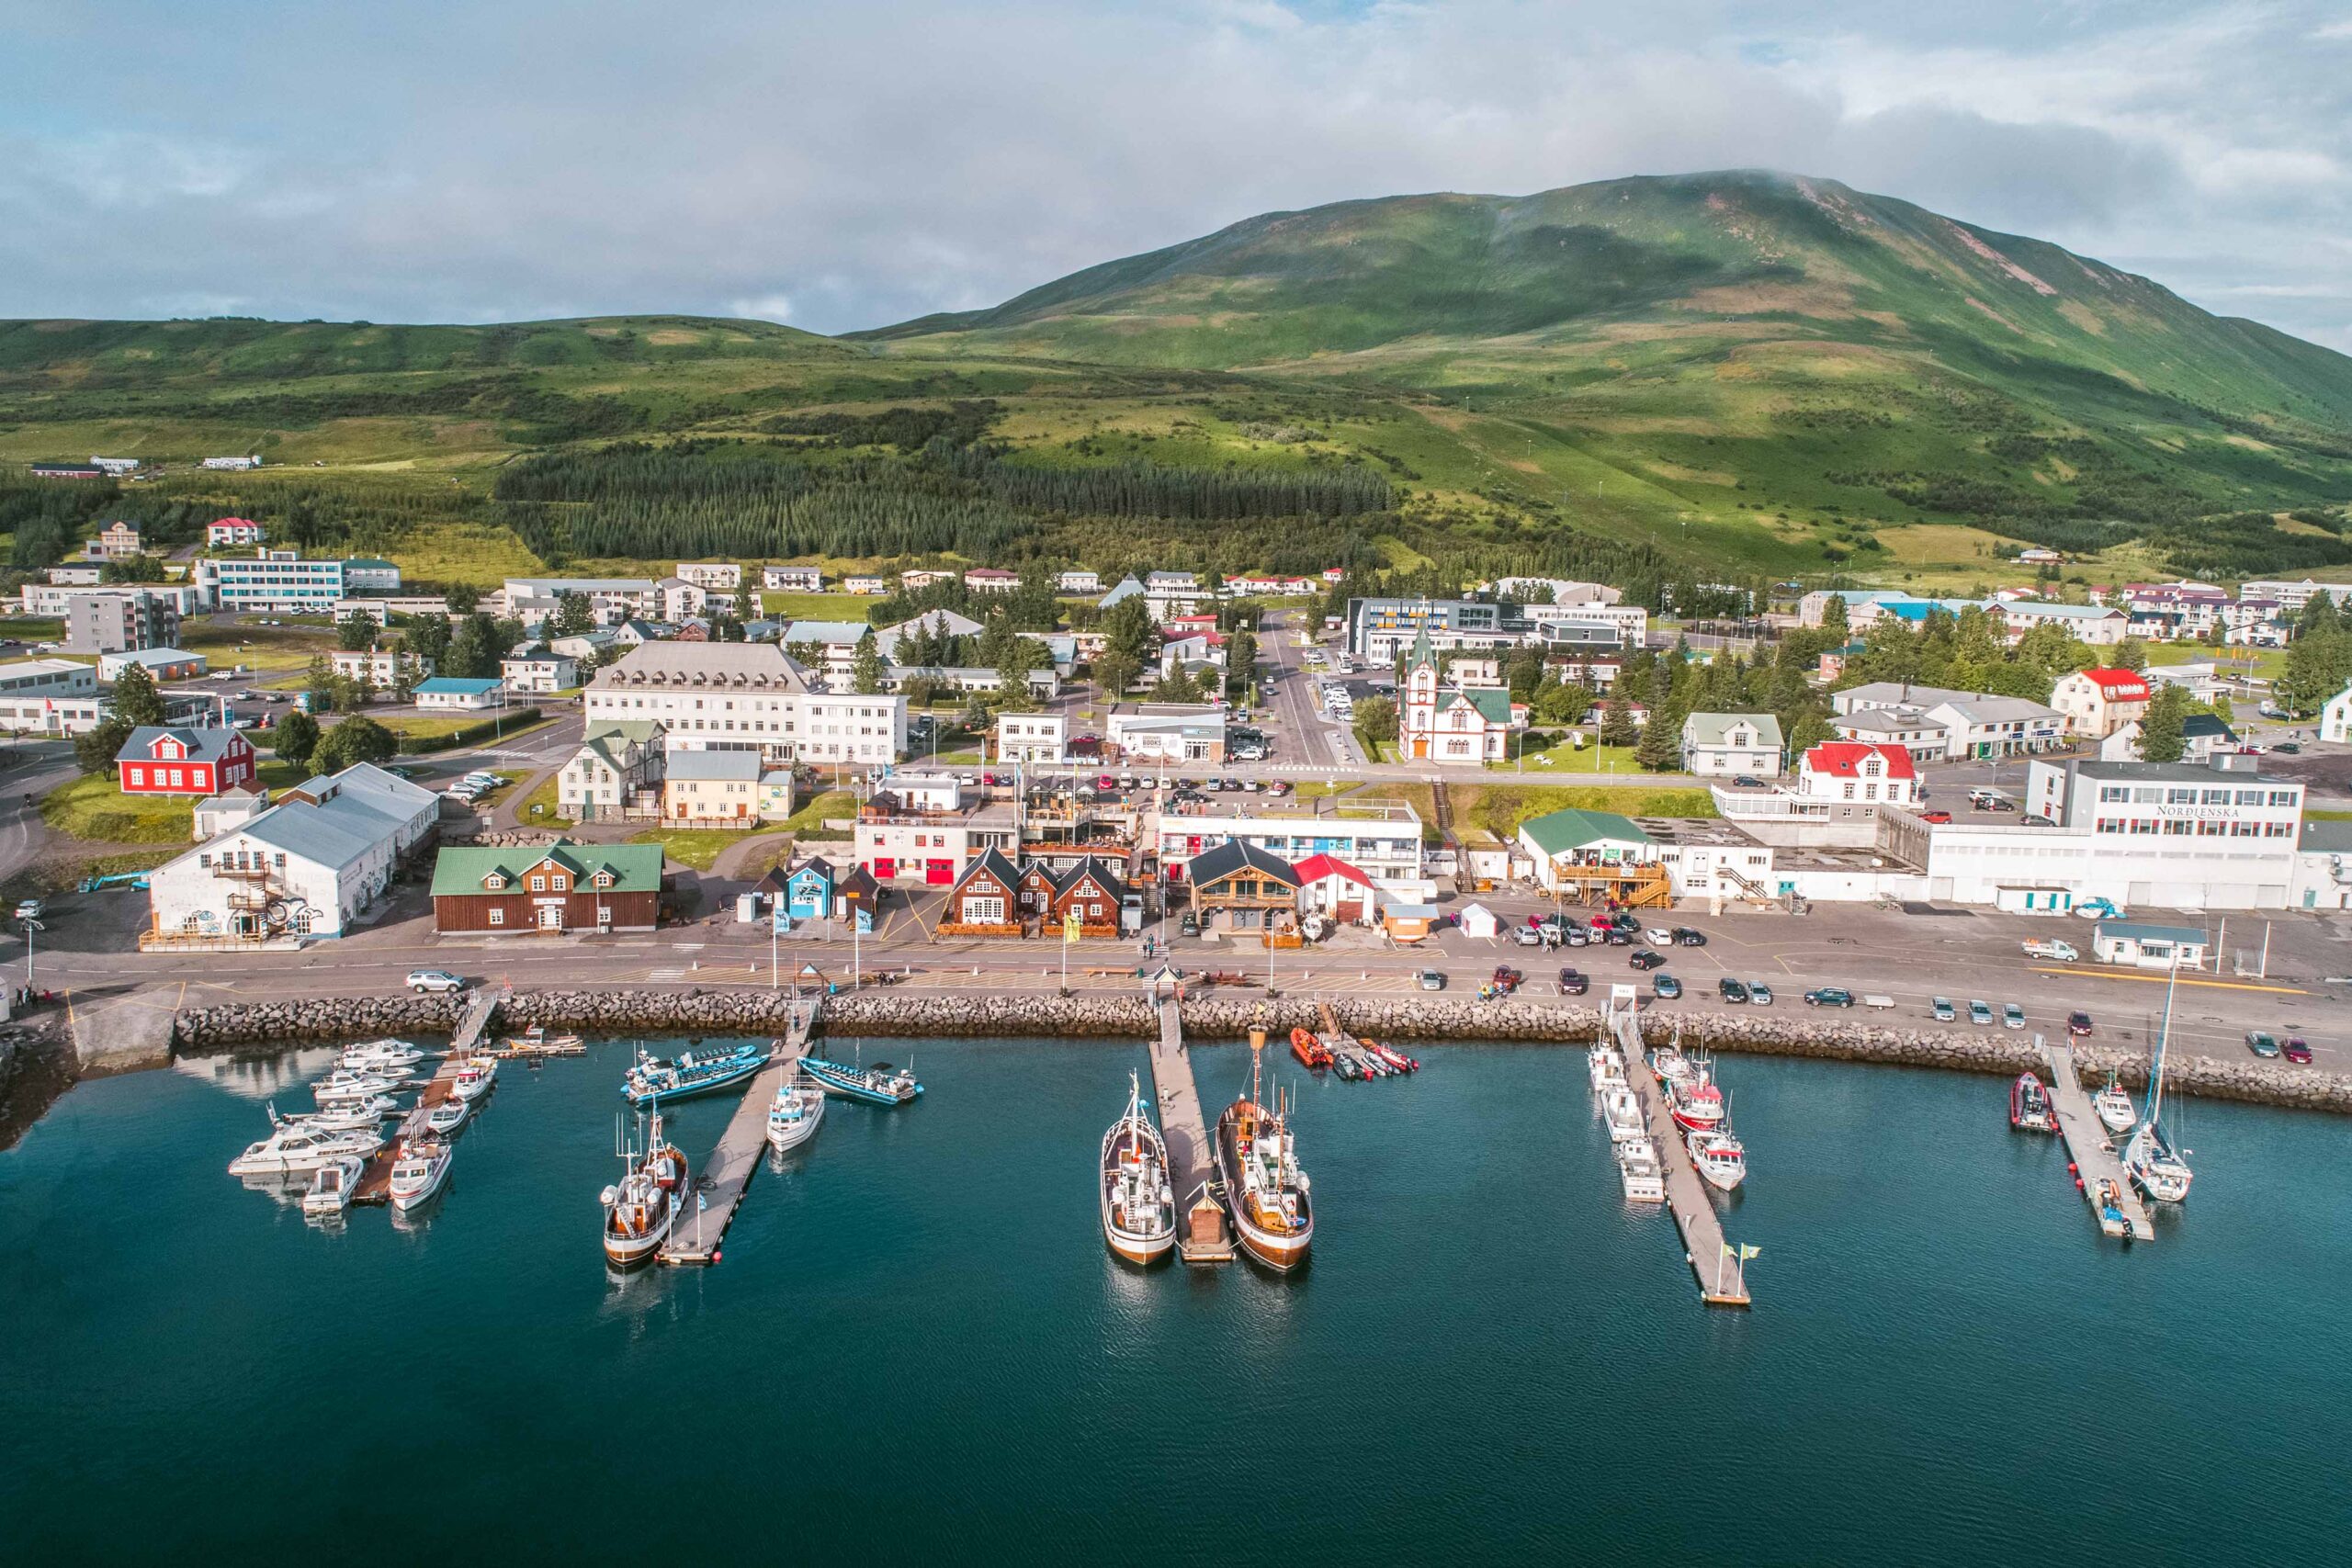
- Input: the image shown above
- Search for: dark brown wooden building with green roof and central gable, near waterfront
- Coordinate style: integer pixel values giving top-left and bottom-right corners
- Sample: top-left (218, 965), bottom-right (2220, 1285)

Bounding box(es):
top-left (433, 840), bottom-right (661, 933)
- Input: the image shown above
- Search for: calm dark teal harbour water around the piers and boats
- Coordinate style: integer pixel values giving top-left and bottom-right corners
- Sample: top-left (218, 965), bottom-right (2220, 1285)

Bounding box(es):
top-left (0, 1042), bottom-right (2352, 1563)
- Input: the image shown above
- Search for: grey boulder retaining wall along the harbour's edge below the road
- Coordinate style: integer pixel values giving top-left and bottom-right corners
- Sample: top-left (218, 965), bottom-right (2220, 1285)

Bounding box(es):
top-left (176, 989), bottom-right (2352, 1114)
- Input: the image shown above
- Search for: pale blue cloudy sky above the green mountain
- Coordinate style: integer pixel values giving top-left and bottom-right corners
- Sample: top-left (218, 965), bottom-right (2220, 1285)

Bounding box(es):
top-left (0, 0), bottom-right (2352, 353)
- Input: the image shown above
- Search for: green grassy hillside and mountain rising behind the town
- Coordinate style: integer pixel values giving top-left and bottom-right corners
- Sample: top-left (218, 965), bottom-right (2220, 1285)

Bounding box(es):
top-left (0, 172), bottom-right (2352, 590)
